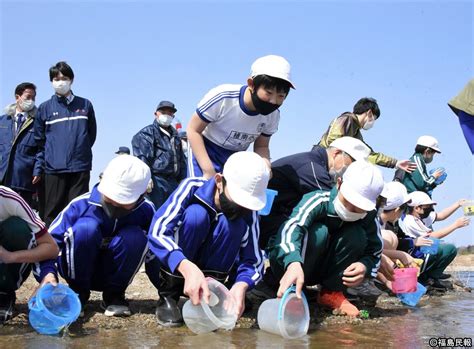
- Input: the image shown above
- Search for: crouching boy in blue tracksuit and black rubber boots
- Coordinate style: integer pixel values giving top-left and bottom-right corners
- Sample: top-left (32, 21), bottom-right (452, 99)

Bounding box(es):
top-left (147, 152), bottom-right (270, 326)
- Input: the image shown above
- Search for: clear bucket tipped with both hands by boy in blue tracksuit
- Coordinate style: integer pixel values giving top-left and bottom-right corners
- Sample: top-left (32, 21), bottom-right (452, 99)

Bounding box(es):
top-left (182, 277), bottom-right (237, 334)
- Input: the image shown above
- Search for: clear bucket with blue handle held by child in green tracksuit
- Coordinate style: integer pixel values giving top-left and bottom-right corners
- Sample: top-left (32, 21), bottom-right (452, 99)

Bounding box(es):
top-left (257, 286), bottom-right (309, 339)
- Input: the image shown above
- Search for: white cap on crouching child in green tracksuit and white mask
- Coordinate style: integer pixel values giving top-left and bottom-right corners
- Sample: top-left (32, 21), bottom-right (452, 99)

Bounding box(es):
top-left (339, 161), bottom-right (384, 211)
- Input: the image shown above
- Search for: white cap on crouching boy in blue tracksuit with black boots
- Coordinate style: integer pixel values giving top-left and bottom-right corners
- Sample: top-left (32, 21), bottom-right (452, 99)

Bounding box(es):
top-left (222, 151), bottom-right (270, 211)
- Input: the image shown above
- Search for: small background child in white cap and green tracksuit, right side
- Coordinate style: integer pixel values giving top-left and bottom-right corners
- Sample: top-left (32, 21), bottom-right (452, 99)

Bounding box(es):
top-left (395, 136), bottom-right (443, 193)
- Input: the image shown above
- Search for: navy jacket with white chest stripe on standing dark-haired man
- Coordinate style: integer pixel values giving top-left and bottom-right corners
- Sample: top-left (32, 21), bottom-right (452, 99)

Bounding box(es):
top-left (34, 95), bottom-right (97, 174)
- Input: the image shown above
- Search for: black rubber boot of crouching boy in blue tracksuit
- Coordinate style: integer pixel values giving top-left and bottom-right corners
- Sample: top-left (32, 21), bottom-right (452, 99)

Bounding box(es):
top-left (155, 268), bottom-right (184, 327)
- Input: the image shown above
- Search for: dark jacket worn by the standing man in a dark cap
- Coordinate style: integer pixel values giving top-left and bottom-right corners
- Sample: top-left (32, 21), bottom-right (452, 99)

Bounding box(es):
top-left (132, 120), bottom-right (187, 182)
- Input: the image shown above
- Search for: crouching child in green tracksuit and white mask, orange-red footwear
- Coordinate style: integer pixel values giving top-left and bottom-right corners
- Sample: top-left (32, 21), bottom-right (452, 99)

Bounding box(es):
top-left (269, 161), bottom-right (384, 316)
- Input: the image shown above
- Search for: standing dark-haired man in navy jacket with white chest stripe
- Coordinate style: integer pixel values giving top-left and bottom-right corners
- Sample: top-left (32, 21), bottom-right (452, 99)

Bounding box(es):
top-left (34, 62), bottom-right (97, 225)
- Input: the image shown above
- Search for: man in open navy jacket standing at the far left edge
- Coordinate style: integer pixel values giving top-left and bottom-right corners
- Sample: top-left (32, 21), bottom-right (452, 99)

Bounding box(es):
top-left (0, 82), bottom-right (41, 208)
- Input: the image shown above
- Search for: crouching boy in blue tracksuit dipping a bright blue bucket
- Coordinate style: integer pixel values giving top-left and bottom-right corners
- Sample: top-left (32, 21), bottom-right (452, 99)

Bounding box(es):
top-left (43, 155), bottom-right (154, 316)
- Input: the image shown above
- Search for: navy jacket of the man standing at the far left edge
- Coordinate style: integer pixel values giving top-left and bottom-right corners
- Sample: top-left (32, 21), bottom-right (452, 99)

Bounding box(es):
top-left (0, 104), bottom-right (41, 192)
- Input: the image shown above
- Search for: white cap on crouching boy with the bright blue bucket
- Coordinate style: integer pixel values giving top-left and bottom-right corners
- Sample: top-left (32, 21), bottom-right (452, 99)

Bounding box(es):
top-left (97, 155), bottom-right (151, 205)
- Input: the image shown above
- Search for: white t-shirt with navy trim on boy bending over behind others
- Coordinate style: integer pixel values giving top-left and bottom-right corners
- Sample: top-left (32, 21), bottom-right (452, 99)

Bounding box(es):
top-left (196, 84), bottom-right (280, 151)
